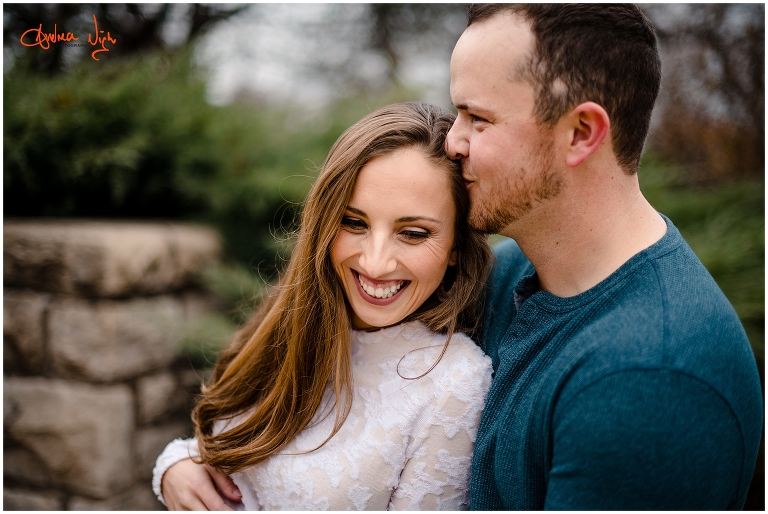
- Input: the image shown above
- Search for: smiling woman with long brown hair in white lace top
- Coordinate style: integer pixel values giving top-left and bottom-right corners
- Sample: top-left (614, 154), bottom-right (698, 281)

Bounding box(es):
top-left (153, 103), bottom-right (491, 510)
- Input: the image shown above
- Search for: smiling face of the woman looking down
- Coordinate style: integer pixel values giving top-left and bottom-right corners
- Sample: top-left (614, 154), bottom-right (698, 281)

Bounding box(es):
top-left (331, 148), bottom-right (456, 328)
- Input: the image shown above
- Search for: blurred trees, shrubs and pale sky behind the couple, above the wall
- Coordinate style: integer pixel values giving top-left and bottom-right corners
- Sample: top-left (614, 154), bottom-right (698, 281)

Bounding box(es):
top-left (3, 4), bottom-right (765, 508)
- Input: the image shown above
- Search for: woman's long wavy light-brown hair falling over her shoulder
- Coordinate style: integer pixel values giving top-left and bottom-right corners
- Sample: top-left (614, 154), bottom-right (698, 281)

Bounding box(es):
top-left (192, 103), bottom-right (491, 473)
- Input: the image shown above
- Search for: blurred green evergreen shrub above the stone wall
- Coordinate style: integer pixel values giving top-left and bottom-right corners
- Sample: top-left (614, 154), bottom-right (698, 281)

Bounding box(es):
top-left (3, 51), bottom-right (402, 268)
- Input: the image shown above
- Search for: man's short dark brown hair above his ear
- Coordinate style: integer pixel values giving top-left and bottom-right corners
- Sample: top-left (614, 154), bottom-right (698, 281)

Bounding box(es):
top-left (467, 4), bottom-right (661, 173)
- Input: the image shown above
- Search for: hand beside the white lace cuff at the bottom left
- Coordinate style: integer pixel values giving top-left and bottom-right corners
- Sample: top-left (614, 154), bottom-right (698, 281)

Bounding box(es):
top-left (160, 459), bottom-right (243, 510)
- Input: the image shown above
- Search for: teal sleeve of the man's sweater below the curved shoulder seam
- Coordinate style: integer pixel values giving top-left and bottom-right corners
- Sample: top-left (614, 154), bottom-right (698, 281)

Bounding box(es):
top-left (545, 369), bottom-right (745, 510)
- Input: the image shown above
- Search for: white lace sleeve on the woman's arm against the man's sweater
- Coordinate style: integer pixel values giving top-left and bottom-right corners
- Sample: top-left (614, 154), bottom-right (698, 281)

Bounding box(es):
top-left (389, 348), bottom-right (492, 510)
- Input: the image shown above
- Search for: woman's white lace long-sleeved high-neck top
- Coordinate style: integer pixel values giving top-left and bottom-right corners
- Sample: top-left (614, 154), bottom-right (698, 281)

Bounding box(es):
top-left (153, 322), bottom-right (492, 510)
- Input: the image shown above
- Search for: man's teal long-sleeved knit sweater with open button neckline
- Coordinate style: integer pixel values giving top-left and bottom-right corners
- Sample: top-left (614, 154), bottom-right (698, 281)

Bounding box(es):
top-left (470, 214), bottom-right (763, 510)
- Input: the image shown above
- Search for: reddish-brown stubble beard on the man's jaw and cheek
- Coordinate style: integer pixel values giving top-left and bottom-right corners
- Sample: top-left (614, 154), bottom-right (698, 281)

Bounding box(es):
top-left (468, 137), bottom-right (563, 234)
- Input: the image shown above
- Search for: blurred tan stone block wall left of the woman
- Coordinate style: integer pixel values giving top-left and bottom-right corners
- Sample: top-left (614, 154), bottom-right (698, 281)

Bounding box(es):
top-left (3, 221), bottom-right (220, 510)
